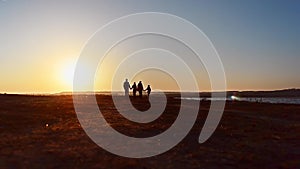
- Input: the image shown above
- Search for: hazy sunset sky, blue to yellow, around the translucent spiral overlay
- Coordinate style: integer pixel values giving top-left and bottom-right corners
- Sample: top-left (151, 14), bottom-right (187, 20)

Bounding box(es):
top-left (0, 0), bottom-right (300, 93)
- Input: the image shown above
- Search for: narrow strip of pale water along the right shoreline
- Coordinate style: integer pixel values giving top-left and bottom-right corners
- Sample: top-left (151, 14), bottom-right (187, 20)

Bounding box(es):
top-left (176, 96), bottom-right (300, 104)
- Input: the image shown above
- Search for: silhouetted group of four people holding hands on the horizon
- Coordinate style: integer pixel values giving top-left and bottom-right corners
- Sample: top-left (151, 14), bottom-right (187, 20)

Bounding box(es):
top-left (123, 79), bottom-right (151, 97)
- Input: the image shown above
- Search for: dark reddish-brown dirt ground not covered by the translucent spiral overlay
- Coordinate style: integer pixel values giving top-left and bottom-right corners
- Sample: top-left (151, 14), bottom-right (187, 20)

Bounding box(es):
top-left (0, 95), bottom-right (300, 169)
